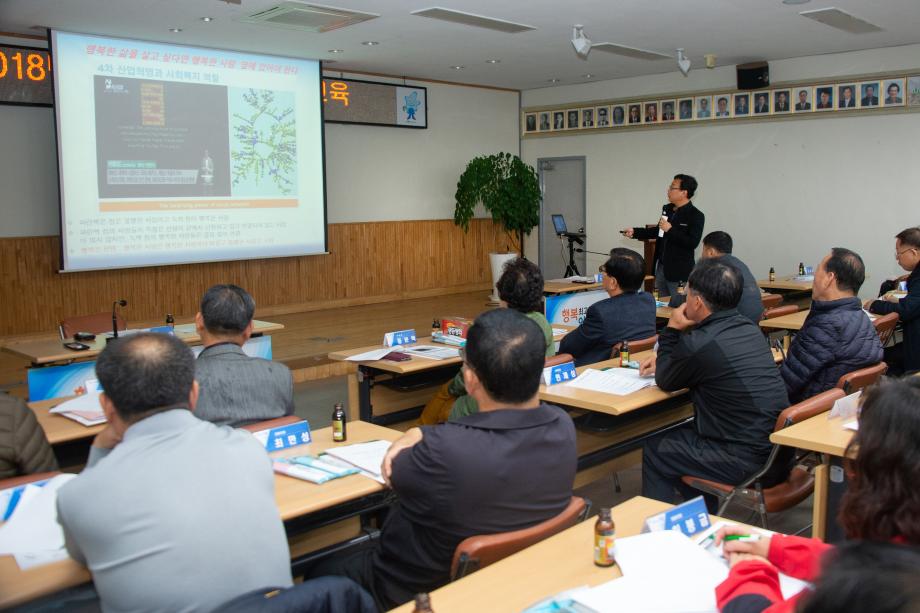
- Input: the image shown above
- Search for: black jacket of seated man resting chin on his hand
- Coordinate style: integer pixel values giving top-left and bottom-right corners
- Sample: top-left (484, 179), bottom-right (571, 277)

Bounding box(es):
top-left (655, 309), bottom-right (789, 458)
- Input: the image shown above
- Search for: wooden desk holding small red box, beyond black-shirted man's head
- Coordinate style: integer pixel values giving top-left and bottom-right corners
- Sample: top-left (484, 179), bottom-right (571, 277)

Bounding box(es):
top-left (329, 324), bottom-right (577, 424)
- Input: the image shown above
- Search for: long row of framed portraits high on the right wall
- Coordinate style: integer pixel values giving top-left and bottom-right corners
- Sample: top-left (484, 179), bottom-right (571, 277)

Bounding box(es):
top-left (524, 76), bottom-right (920, 134)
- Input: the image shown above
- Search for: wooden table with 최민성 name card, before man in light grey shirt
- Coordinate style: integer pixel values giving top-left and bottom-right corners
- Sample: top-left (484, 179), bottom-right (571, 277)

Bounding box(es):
top-left (0, 422), bottom-right (402, 609)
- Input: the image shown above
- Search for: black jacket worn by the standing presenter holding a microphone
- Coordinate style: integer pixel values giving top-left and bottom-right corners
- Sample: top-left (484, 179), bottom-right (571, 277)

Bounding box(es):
top-left (633, 202), bottom-right (706, 283)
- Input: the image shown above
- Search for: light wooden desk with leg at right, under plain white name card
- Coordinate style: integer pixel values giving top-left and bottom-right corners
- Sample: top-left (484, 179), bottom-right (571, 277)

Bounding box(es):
top-left (770, 412), bottom-right (856, 543)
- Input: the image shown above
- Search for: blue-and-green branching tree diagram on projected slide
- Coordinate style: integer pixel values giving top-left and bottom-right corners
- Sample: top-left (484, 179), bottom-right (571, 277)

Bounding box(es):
top-left (231, 89), bottom-right (297, 194)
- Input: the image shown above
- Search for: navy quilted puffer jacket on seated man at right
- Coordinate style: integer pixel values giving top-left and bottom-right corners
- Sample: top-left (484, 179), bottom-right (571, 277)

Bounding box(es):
top-left (779, 297), bottom-right (883, 403)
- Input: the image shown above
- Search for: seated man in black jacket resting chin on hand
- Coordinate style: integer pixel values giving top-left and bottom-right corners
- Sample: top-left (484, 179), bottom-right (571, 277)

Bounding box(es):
top-left (642, 259), bottom-right (789, 510)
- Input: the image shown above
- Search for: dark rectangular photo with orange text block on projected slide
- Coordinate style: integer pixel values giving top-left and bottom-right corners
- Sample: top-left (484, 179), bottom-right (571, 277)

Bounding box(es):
top-left (95, 75), bottom-right (230, 198)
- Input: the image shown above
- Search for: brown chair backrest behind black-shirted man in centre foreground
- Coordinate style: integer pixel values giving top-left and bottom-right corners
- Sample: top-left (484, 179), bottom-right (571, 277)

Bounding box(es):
top-left (450, 496), bottom-right (586, 580)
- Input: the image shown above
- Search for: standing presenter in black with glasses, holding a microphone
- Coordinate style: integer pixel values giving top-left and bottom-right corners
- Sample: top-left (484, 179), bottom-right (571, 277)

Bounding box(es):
top-left (623, 174), bottom-right (706, 297)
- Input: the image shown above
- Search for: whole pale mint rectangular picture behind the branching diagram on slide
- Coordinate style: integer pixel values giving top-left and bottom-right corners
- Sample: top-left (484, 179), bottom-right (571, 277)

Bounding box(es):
top-left (228, 87), bottom-right (297, 198)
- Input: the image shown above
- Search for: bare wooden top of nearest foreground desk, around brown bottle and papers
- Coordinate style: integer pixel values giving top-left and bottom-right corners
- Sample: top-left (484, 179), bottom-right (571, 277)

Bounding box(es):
top-left (394, 496), bottom-right (688, 613)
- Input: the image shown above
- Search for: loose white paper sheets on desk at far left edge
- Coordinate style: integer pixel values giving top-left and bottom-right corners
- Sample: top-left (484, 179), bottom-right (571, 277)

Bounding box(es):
top-left (0, 474), bottom-right (76, 569)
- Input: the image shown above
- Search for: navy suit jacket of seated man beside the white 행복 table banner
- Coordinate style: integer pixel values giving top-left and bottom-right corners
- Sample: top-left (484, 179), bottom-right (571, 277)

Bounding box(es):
top-left (559, 292), bottom-right (655, 366)
